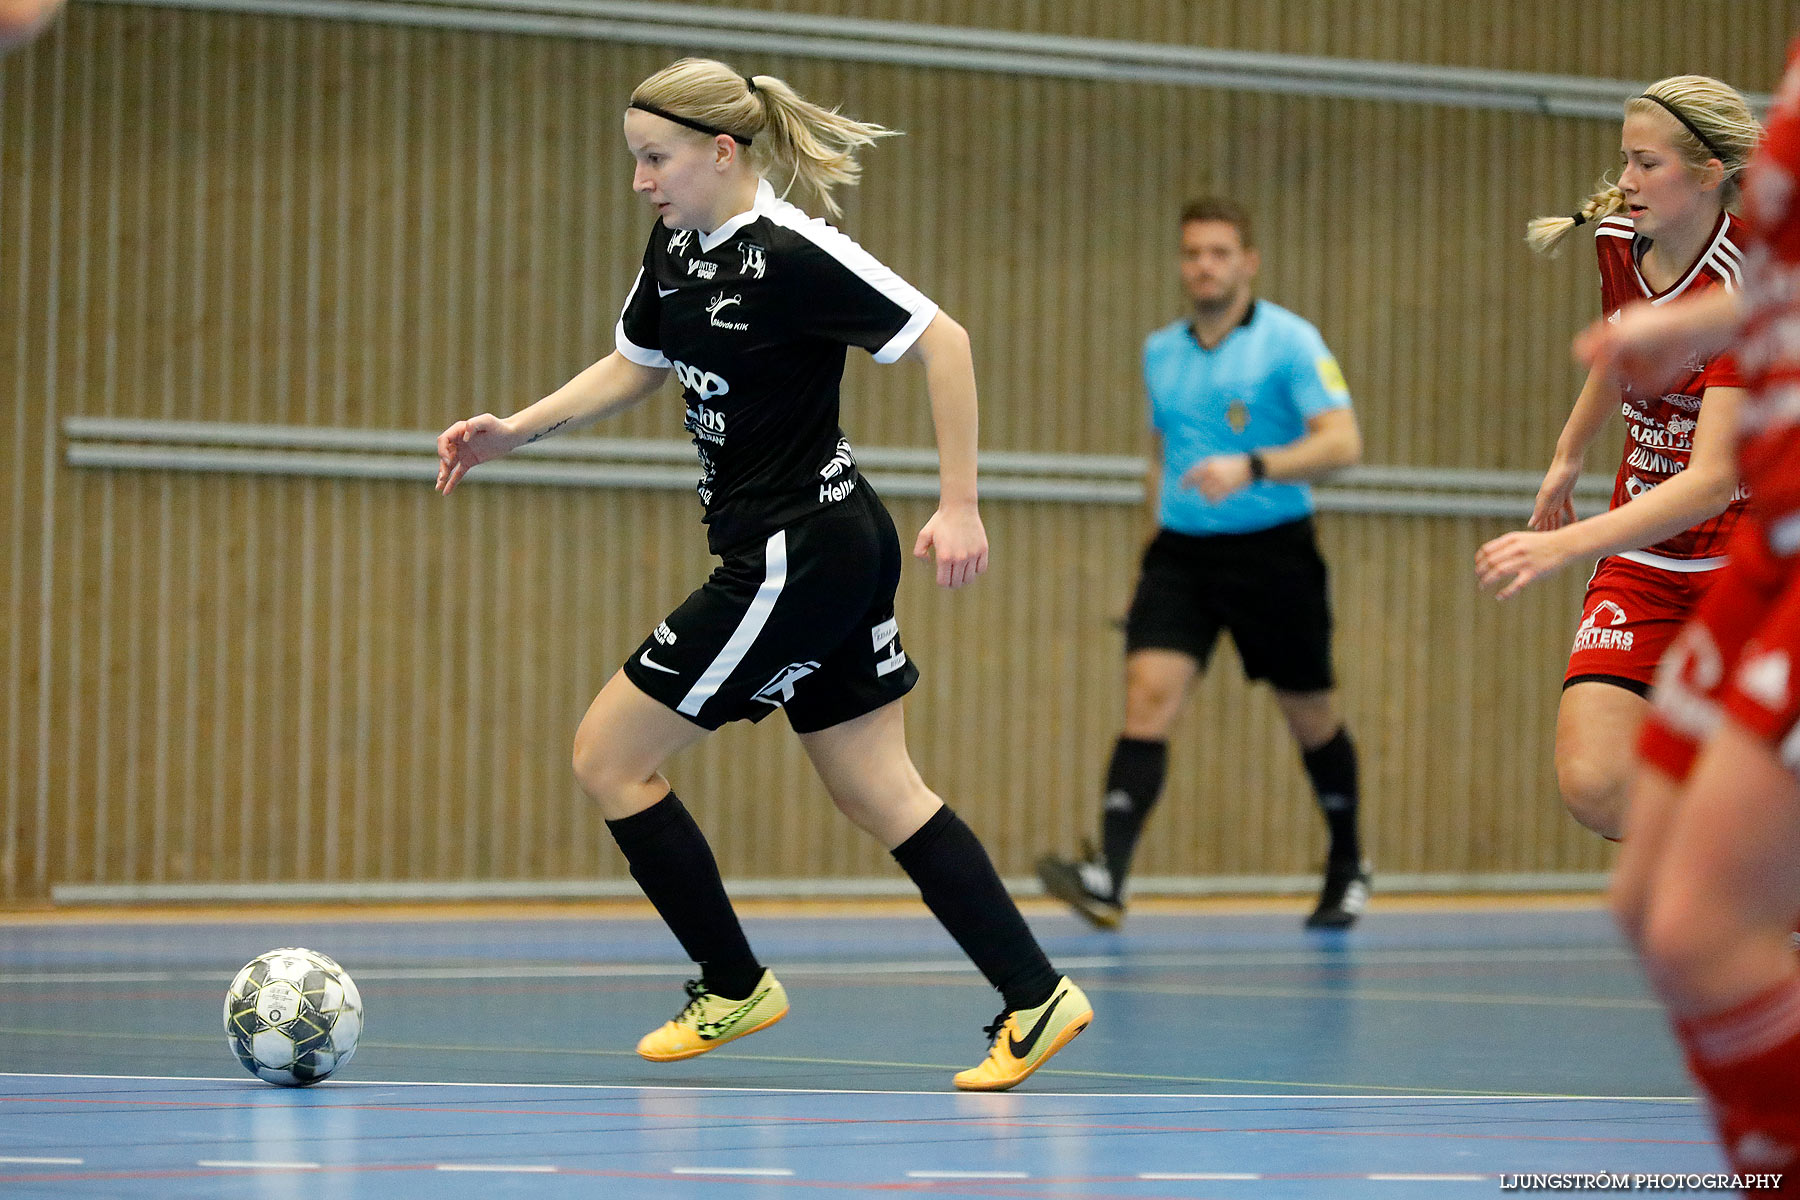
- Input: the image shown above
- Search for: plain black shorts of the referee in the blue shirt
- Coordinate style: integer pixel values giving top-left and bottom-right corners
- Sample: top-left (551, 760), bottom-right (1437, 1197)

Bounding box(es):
top-left (1125, 518), bottom-right (1336, 693)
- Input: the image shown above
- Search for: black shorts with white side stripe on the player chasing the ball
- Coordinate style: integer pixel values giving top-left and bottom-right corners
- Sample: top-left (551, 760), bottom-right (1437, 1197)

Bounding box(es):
top-left (625, 479), bottom-right (918, 734)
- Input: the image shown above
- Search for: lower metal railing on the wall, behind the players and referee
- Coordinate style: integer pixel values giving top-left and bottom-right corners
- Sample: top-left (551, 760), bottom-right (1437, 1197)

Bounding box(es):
top-left (63, 417), bottom-right (1613, 518)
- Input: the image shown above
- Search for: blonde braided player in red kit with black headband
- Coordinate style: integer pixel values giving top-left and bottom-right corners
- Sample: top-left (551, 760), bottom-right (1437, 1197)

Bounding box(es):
top-left (1476, 76), bottom-right (1760, 840)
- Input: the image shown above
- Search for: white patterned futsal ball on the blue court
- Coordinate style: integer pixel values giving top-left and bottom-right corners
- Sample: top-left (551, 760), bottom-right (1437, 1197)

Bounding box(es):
top-left (225, 946), bottom-right (362, 1087)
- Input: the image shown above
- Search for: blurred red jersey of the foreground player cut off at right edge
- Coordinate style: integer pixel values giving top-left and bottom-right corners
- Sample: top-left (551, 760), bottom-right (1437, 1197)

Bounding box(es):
top-left (1739, 40), bottom-right (1800, 536)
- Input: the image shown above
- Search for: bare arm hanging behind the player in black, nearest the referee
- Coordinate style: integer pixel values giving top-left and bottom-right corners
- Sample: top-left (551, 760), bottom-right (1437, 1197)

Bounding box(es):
top-left (905, 311), bottom-right (988, 588)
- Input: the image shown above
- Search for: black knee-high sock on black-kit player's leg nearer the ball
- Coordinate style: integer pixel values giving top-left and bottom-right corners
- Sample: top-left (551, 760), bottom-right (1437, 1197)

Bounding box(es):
top-left (607, 792), bottom-right (763, 1000)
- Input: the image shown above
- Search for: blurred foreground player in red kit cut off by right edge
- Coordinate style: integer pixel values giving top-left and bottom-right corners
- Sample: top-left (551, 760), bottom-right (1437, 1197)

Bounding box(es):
top-left (1605, 41), bottom-right (1800, 1191)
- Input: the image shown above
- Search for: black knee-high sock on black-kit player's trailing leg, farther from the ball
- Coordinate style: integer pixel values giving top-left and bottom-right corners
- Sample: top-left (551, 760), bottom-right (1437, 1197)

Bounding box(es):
top-left (893, 804), bottom-right (1060, 1009)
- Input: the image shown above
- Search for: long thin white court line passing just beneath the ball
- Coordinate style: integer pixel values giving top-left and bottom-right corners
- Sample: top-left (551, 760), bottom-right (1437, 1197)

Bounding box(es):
top-left (0, 1070), bottom-right (1699, 1105)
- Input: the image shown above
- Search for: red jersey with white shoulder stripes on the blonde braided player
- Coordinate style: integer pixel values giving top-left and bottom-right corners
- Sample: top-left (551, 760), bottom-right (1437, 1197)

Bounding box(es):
top-left (1595, 212), bottom-right (1746, 570)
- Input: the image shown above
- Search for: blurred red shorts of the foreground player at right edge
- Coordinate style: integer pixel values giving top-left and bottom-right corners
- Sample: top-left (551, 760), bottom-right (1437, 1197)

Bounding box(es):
top-left (1640, 520), bottom-right (1800, 779)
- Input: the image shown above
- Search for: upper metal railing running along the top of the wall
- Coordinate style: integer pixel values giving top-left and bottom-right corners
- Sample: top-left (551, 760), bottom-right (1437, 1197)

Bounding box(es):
top-left (88, 0), bottom-right (1769, 121)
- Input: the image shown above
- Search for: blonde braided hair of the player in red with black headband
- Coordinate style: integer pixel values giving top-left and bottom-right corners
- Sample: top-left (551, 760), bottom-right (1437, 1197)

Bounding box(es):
top-left (1525, 76), bottom-right (1762, 255)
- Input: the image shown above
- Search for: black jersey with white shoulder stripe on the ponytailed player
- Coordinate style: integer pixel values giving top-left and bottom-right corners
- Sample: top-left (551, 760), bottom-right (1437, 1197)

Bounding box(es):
top-left (616, 182), bottom-right (938, 552)
